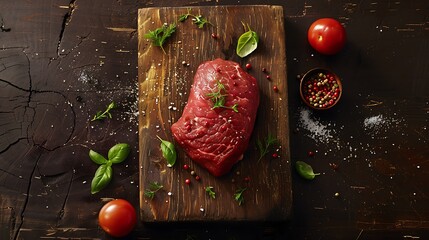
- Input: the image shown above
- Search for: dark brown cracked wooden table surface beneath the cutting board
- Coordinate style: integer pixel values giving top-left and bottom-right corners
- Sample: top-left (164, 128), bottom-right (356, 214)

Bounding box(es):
top-left (0, 0), bottom-right (429, 239)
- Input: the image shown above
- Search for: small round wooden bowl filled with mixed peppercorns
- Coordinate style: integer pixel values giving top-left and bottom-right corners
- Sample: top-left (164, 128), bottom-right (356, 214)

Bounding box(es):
top-left (299, 68), bottom-right (343, 110)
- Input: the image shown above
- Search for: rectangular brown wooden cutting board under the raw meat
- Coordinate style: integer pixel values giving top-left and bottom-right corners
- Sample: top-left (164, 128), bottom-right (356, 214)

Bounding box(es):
top-left (138, 6), bottom-right (292, 222)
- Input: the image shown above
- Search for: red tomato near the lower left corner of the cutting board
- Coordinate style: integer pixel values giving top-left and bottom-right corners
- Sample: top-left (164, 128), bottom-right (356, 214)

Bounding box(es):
top-left (98, 199), bottom-right (137, 237)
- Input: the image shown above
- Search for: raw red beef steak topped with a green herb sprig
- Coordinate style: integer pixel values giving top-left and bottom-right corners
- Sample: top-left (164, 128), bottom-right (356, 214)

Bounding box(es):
top-left (171, 59), bottom-right (259, 176)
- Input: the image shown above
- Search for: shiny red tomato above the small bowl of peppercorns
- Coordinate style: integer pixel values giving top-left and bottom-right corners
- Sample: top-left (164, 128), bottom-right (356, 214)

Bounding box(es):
top-left (307, 18), bottom-right (346, 55)
